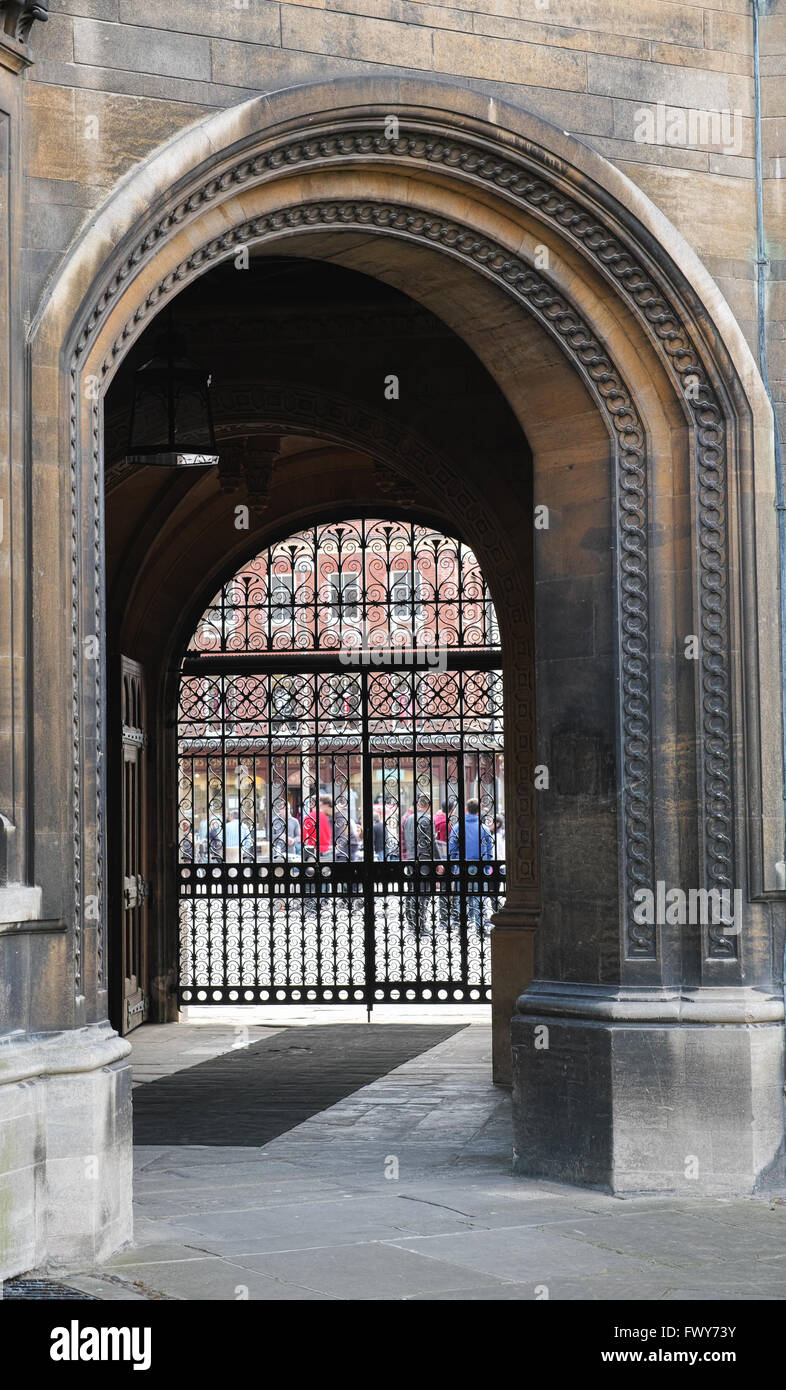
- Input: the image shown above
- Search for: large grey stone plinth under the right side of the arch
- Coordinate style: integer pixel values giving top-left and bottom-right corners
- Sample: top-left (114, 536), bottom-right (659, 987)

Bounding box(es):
top-left (512, 981), bottom-right (783, 1195)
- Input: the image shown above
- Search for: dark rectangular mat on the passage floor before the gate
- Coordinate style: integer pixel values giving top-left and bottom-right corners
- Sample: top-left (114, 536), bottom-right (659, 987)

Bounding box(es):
top-left (134, 1023), bottom-right (466, 1148)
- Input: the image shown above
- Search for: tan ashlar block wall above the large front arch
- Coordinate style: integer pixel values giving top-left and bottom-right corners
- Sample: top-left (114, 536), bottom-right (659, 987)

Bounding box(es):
top-left (24, 0), bottom-right (786, 447)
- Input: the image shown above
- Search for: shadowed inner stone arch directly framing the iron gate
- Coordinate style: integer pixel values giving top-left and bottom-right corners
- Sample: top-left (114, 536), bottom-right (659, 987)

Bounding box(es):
top-left (105, 405), bottom-right (538, 1056)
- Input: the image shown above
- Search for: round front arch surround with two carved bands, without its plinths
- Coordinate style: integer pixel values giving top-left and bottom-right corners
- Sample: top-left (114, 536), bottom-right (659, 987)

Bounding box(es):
top-left (29, 70), bottom-right (782, 1195)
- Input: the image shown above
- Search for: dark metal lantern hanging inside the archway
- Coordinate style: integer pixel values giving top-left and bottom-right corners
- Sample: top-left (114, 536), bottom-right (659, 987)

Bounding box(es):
top-left (127, 311), bottom-right (218, 468)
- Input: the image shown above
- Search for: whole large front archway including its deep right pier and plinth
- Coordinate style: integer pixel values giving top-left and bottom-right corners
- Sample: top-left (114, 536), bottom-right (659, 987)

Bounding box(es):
top-left (18, 79), bottom-right (783, 1217)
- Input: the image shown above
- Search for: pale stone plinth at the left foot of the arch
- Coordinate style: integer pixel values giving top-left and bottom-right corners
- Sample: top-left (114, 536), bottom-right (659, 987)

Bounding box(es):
top-left (0, 1023), bottom-right (132, 1279)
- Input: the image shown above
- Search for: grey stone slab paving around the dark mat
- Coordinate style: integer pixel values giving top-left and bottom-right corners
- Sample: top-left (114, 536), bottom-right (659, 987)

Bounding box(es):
top-left (68, 1019), bottom-right (786, 1301)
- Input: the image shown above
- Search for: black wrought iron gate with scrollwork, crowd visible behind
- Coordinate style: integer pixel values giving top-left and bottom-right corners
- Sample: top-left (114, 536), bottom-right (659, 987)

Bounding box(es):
top-left (178, 521), bottom-right (505, 1008)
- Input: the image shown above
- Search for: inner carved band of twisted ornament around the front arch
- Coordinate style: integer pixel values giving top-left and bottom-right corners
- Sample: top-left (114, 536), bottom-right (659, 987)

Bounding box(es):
top-left (93, 200), bottom-right (657, 959)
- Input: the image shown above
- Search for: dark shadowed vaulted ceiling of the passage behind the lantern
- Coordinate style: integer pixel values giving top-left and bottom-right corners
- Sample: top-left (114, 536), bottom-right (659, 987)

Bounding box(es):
top-left (104, 256), bottom-right (530, 650)
